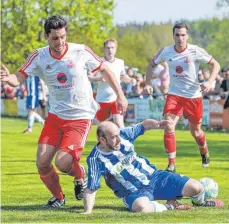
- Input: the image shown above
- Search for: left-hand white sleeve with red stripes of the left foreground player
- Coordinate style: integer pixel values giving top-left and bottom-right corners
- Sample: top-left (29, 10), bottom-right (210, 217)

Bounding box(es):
top-left (19, 50), bottom-right (40, 78)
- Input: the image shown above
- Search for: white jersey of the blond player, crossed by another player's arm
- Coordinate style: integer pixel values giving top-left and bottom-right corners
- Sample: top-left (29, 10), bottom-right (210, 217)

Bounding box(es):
top-left (96, 58), bottom-right (126, 103)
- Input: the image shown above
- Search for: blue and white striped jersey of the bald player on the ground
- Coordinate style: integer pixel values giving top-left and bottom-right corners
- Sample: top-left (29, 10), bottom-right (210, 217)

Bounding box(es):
top-left (87, 124), bottom-right (156, 197)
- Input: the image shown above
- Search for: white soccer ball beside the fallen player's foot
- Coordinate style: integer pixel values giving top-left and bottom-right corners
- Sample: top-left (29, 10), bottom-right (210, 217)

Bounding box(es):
top-left (200, 177), bottom-right (219, 199)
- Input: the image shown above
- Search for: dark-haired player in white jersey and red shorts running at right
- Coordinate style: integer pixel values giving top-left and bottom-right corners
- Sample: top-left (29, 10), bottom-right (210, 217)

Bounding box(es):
top-left (145, 23), bottom-right (220, 172)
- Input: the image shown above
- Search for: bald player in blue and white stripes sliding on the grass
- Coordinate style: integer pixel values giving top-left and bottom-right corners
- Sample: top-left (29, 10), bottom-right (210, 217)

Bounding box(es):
top-left (84, 119), bottom-right (224, 214)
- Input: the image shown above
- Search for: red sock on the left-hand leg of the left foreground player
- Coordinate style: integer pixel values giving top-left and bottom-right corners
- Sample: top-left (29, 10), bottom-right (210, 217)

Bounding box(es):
top-left (40, 167), bottom-right (64, 200)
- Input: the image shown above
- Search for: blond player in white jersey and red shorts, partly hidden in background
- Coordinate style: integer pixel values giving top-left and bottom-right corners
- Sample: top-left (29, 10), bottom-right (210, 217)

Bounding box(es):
top-left (89, 38), bottom-right (136, 128)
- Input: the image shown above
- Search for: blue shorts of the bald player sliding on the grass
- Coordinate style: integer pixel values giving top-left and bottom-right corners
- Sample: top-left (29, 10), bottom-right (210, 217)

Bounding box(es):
top-left (123, 170), bottom-right (190, 210)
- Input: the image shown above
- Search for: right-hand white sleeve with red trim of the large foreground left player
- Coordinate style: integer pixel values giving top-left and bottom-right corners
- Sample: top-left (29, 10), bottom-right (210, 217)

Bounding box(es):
top-left (84, 46), bottom-right (103, 73)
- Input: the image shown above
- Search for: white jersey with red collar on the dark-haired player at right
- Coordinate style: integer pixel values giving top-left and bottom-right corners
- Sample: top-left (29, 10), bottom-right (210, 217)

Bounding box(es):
top-left (153, 44), bottom-right (212, 98)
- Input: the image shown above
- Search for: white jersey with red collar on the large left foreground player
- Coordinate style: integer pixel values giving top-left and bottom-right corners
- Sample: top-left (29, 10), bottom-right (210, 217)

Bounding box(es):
top-left (19, 43), bottom-right (102, 120)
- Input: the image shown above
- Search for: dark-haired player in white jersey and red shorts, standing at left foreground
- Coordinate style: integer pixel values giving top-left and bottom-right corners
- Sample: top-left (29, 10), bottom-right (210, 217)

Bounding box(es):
top-left (0, 15), bottom-right (127, 207)
